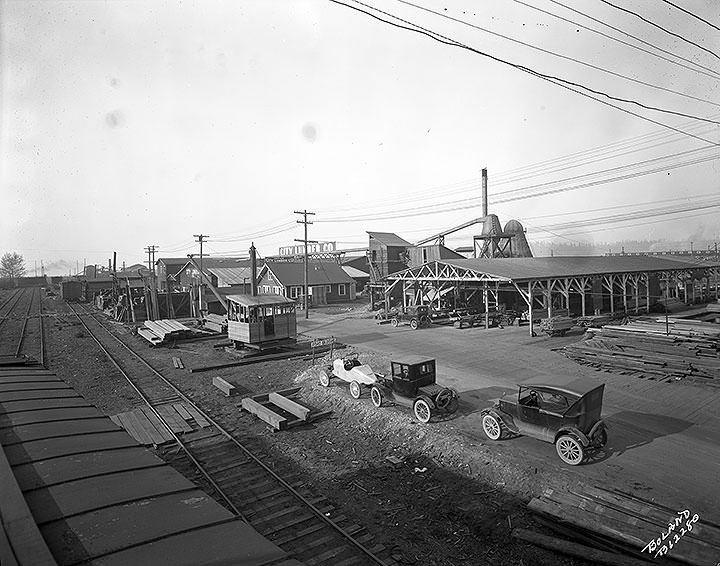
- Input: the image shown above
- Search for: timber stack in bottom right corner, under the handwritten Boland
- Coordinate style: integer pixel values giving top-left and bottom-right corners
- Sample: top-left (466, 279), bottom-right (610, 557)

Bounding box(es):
top-left (528, 486), bottom-right (720, 566)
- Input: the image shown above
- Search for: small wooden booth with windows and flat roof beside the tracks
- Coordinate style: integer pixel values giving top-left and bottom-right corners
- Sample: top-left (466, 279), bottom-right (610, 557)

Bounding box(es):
top-left (226, 293), bottom-right (297, 349)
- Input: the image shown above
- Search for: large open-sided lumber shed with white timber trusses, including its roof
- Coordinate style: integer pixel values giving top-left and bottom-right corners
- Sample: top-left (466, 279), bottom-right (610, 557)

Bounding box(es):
top-left (385, 256), bottom-right (720, 332)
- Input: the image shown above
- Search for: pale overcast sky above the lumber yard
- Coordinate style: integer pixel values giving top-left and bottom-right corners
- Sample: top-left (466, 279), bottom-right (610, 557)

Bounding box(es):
top-left (0, 0), bottom-right (720, 274)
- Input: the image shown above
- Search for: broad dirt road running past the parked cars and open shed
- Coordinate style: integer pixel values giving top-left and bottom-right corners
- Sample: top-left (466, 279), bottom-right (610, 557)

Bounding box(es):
top-left (298, 312), bottom-right (720, 522)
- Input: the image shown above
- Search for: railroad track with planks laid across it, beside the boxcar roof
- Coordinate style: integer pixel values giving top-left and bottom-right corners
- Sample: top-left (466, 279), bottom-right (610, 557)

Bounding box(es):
top-left (70, 305), bottom-right (396, 566)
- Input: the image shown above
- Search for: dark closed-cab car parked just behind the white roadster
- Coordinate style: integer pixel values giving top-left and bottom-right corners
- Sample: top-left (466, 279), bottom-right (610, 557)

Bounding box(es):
top-left (370, 357), bottom-right (458, 423)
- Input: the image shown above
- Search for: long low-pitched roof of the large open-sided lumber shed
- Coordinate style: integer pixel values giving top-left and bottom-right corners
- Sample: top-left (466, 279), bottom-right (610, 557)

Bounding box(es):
top-left (441, 256), bottom-right (720, 281)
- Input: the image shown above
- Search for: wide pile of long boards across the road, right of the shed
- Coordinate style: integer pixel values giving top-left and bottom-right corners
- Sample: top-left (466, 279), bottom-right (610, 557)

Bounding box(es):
top-left (563, 318), bottom-right (720, 380)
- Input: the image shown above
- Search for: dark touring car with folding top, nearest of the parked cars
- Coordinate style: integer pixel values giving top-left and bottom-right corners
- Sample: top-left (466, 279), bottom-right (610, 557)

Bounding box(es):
top-left (480, 379), bottom-right (607, 466)
